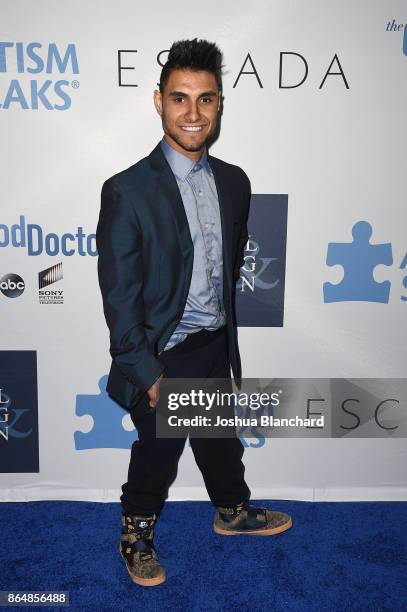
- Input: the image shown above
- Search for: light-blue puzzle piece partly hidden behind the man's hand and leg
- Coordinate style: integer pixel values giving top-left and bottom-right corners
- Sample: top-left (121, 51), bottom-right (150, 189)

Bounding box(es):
top-left (74, 376), bottom-right (137, 450)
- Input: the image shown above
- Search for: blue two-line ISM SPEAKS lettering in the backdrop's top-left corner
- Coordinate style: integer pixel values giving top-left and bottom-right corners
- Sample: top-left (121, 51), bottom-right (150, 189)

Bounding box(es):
top-left (0, 41), bottom-right (80, 111)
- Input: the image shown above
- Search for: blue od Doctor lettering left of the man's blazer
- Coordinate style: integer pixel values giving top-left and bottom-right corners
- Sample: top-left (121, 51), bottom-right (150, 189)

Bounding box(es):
top-left (0, 215), bottom-right (98, 257)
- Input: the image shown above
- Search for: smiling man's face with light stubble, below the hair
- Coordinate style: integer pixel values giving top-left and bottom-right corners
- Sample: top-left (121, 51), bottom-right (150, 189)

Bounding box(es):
top-left (154, 69), bottom-right (220, 160)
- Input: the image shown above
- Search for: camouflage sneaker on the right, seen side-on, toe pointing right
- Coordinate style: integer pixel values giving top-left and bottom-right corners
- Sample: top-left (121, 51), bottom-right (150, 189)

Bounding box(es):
top-left (213, 502), bottom-right (292, 535)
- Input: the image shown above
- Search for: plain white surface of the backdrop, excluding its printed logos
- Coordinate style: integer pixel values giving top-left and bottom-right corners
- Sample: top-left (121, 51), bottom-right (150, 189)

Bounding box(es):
top-left (0, 0), bottom-right (407, 501)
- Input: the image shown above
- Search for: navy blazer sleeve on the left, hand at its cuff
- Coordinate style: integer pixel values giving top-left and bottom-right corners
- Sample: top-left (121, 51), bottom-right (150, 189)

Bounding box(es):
top-left (96, 177), bottom-right (164, 391)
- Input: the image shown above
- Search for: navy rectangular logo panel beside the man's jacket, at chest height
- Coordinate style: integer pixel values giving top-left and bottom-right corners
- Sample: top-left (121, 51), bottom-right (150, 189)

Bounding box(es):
top-left (236, 195), bottom-right (288, 327)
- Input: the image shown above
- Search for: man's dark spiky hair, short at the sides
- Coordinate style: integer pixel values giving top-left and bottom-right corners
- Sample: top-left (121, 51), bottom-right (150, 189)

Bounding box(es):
top-left (160, 38), bottom-right (222, 93)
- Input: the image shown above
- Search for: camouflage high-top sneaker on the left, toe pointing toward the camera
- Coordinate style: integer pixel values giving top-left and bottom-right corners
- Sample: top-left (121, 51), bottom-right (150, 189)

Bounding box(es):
top-left (120, 514), bottom-right (165, 586)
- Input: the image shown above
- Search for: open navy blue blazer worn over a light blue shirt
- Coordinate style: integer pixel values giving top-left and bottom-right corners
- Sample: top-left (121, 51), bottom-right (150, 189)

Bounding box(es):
top-left (96, 144), bottom-right (250, 410)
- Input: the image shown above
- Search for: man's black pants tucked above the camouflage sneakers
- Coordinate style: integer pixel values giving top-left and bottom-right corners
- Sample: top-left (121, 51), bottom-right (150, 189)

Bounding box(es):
top-left (120, 328), bottom-right (250, 516)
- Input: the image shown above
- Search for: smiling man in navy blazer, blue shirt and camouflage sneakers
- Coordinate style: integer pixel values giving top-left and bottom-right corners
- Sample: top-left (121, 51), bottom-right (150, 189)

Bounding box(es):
top-left (97, 39), bottom-right (291, 586)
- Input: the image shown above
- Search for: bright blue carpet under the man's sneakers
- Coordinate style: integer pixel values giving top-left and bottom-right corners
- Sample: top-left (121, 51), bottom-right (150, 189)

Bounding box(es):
top-left (0, 501), bottom-right (407, 612)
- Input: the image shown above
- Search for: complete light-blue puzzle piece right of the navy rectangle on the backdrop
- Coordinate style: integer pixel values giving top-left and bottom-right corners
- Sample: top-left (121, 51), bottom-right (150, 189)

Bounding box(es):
top-left (323, 221), bottom-right (393, 304)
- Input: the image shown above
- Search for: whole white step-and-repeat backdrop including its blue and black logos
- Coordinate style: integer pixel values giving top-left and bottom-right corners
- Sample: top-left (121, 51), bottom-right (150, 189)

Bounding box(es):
top-left (0, 0), bottom-right (407, 501)
